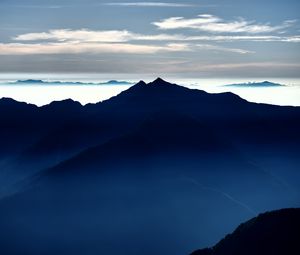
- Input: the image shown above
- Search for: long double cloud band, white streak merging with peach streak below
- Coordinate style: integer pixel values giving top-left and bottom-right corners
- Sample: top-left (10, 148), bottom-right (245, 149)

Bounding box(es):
top-left (8, 29), bottom-right (300, 55)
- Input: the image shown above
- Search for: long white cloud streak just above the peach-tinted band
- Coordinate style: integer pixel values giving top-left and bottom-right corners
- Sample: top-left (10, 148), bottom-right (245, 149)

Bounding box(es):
top-left (13, 29), bottom-right (300, 43)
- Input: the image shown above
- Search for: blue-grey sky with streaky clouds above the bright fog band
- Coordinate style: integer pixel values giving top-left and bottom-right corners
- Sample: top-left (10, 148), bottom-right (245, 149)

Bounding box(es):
top-left (0, 0), bottom-right (300, 78)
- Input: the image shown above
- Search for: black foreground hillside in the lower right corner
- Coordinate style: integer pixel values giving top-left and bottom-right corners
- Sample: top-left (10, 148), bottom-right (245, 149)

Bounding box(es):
top-left (191, 208), bottom-right (300, 255)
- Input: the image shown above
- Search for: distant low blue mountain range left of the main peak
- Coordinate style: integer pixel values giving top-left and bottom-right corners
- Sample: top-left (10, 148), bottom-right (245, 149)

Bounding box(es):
top-left (6, 79), bottom-right (134, 85)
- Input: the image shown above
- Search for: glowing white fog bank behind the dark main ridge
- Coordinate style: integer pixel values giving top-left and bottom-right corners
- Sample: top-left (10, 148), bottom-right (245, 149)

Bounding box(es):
top-left (0, 74), bottom-right (300, 106)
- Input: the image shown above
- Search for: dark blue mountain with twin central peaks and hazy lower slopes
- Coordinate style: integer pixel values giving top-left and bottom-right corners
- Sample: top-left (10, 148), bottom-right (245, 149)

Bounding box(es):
top-left (0, 79), bottom-right (300, 255)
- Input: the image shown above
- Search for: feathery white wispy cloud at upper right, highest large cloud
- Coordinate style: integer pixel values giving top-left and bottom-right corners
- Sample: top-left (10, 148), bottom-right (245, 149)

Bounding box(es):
top-left (152, 14), bottom-right (295, 34)
